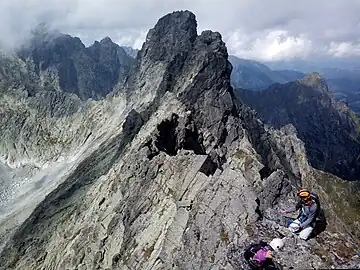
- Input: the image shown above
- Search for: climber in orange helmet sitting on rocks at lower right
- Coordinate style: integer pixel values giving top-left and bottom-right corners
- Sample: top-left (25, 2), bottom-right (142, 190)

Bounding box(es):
top-left (279, 188), bottom-right (320, 240)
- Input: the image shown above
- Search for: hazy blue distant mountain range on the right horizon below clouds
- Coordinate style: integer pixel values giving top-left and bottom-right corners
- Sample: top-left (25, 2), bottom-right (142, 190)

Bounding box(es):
top-left (229, 56), bottom-right (360, 114)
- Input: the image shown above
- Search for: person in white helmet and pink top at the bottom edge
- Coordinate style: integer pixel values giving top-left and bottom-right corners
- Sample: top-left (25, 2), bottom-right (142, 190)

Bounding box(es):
top-left (244, 238), bottom-right (284, 270)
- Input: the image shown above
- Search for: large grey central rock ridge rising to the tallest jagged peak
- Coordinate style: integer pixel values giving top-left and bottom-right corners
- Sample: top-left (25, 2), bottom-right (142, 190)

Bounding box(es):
top-left (0, 11), bottom-right (359, 269)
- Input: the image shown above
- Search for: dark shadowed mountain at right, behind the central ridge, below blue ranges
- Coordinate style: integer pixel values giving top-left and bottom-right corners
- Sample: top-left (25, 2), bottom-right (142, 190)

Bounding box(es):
top-left (238, 73), bottom-right (360, 180)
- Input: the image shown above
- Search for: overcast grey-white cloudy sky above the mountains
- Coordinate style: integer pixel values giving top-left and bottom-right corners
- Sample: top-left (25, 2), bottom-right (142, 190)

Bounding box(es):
top-left (0, 0), bottom-right (360, 60)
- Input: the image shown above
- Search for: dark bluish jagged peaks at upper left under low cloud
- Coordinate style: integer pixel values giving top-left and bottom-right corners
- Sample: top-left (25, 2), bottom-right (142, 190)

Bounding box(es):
top-left (18, 24), bottom-right (132, 100)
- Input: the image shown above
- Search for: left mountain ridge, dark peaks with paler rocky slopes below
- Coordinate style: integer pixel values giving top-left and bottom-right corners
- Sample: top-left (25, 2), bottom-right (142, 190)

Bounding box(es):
top-left (0, 26), bottom-right (133, 167)
